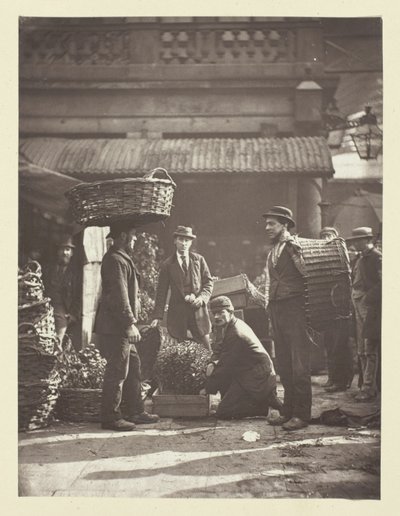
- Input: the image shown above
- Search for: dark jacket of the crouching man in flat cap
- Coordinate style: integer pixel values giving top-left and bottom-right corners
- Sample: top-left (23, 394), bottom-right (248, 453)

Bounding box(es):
top-left (207, 317), bottom-right (276, 402)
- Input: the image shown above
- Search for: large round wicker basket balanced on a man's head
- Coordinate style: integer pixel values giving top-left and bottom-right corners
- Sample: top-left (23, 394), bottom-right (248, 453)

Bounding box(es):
top-left (65, 168), bottom-right (176, 226)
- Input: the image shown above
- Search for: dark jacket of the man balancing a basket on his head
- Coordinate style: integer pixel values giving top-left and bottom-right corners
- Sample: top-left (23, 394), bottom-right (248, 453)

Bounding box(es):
top-left (94, 247), bottom-right (140, 335)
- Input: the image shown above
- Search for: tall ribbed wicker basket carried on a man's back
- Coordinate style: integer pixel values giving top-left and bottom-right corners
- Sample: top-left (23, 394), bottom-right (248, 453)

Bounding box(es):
top-left (299, 238), bottom-right (351, 331)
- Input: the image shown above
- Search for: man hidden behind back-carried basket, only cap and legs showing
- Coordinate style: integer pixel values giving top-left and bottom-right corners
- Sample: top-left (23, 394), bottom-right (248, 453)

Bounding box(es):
top-left (319, 226), bottom-right (353, 392)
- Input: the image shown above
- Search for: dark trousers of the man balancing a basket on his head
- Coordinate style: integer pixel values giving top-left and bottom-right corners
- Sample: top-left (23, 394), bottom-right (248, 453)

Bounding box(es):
top-left (98, 335), bottom-right (144, 423)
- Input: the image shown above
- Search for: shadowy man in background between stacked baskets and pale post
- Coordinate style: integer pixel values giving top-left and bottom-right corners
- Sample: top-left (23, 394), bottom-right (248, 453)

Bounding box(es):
top-left (43, 235), bottom-right (82, 349)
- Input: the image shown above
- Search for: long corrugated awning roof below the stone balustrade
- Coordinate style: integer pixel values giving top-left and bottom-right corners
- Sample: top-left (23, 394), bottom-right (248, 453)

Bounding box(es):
top-left (20, 137), bottom-right (334, 176)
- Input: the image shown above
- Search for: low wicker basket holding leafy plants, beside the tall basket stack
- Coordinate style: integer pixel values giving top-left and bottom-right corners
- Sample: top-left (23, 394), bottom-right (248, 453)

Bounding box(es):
top-left (56, 387), bottom-right (102, 422)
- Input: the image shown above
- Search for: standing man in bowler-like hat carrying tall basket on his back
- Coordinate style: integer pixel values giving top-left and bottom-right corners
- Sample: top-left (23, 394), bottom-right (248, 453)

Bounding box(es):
top-left (263, 206), bottom-right (312, 430)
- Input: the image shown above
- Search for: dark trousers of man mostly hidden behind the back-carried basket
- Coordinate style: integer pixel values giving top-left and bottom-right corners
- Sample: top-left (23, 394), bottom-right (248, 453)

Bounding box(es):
top-left (324, 319), bottom-right (353, 387)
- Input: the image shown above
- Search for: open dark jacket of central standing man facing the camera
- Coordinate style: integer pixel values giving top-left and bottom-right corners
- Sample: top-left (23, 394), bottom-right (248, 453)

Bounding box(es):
top-left (153, 253), bottom-right (214, 340)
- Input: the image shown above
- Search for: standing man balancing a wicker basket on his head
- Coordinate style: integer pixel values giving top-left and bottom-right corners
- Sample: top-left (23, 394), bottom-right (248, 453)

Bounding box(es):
top-left (94, 222), bottom-right (159, 431)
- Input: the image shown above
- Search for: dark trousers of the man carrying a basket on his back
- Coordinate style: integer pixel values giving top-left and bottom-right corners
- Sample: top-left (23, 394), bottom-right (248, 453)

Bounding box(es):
top-left (269, 296), bottom-right (312, 421)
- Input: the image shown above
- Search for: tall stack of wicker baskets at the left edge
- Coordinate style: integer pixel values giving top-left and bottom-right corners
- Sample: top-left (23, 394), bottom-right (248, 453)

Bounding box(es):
top-left (18, 262), bottom-right (60, 430)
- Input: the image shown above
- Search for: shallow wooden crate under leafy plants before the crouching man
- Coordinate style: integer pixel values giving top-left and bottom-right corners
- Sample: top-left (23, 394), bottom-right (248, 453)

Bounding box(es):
top-left (153, 389), bottom-right (210, 417)
